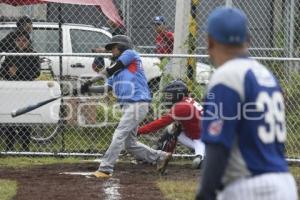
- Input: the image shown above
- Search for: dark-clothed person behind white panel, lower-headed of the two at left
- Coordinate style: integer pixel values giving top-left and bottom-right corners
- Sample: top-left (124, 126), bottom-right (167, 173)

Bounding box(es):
top-left (0, 30), bottom-right (40, 151)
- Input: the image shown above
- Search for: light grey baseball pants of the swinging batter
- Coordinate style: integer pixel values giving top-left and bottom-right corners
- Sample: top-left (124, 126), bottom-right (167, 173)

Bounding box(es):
top-left (99, 103), bottom-right (166, 173)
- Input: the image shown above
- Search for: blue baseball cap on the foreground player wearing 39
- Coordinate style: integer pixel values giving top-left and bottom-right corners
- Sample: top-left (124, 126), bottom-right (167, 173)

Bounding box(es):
top-left (206, 7), bottom-right (249, 45)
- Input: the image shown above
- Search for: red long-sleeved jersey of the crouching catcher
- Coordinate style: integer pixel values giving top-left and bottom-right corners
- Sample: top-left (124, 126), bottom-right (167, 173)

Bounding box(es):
top-left (138, 97), bottom-right (203, 139)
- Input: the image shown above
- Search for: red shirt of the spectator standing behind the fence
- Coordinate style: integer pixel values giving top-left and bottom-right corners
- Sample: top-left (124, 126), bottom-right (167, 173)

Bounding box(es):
top-left (156, 32), bottom-right (174, 54)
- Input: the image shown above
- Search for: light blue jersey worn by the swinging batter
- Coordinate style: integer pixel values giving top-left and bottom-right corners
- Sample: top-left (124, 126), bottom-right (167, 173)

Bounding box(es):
top-left (107, 49), bottom-right (151, 103)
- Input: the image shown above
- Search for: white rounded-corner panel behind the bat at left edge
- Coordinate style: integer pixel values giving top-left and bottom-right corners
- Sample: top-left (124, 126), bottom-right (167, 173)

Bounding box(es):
top-left (0, 81), bottom-right (61, 124)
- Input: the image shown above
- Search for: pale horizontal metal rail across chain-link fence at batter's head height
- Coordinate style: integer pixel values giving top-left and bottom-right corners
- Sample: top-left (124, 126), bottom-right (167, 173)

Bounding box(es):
top-left (0, 53), bottom-right (300, 61)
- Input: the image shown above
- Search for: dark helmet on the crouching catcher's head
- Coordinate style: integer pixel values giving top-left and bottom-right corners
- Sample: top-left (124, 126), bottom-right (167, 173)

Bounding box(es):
top-left (162, 80), bottom-right (189, 104)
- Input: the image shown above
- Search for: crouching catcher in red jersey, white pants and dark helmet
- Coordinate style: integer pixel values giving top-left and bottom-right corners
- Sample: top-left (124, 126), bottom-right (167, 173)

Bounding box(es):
top-left (138, 80), bottom-right (205, 168)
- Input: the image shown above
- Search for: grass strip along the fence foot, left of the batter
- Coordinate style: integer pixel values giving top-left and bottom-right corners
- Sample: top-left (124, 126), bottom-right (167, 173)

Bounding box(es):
top-left (0, 157), bottom-right (81, 168)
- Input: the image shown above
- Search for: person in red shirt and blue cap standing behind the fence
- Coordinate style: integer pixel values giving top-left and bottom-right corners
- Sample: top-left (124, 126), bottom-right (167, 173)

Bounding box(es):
top-left (154, 16), bottom-right (174, 54)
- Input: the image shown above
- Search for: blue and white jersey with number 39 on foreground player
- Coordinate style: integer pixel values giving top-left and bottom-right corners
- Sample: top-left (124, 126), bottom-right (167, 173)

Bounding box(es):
top-left (202, 58), bottom-right (288, 184)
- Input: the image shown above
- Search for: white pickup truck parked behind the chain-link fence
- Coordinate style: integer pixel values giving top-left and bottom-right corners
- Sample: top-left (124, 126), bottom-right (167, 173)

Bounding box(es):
top-left (0, 22), bottom-right (211, 85)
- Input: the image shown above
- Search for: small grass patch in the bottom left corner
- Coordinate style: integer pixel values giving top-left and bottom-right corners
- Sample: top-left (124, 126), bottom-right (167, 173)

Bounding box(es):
top-left (0, 179), bottom-right (17, 200)
